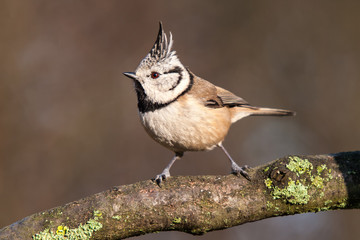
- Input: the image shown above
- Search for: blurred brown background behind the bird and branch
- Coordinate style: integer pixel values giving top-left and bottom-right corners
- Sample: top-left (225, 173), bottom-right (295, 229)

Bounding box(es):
top-left (0, 0), bottom-right (360, 240)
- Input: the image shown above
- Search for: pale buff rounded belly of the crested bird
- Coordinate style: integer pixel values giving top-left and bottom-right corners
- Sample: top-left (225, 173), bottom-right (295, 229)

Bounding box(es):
top-left (140, 98), bottom-right (231, 152)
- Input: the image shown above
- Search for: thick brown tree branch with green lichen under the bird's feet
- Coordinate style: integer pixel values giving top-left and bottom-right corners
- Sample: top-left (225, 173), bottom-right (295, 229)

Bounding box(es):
top-left (0, 151), bottom-right (360, 239)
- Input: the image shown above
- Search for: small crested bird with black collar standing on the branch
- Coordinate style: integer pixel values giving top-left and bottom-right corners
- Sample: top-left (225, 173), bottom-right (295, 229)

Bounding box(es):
top-left (123, 22), bottom-right (295, 184)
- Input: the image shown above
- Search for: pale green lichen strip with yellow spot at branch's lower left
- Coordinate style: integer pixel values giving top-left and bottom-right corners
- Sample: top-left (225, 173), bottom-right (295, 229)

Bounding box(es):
top-left (33, 211), bottom-right (102, 240)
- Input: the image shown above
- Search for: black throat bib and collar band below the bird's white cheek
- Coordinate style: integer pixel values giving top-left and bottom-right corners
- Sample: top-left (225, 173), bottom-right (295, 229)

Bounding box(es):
top-left (135, 71), bottom-right (194, 113)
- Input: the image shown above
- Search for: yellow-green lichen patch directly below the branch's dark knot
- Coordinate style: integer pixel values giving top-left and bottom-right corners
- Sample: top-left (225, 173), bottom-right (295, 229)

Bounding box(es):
top-left (272, 179), bottom-right (310, 204)
